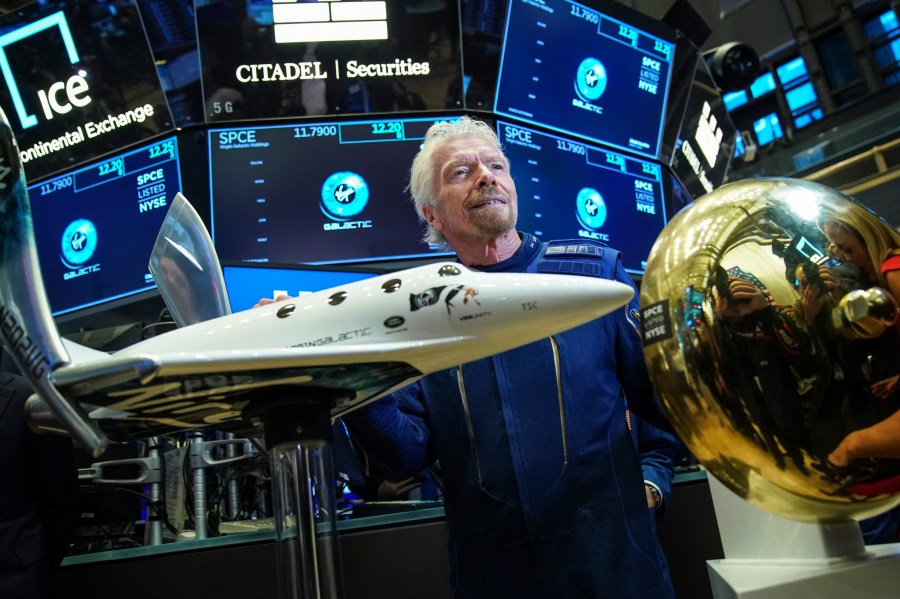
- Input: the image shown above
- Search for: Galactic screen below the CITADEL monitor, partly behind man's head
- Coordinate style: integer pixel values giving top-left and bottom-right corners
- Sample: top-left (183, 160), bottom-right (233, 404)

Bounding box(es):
top-left (208, 117), bottom-right (453, 264)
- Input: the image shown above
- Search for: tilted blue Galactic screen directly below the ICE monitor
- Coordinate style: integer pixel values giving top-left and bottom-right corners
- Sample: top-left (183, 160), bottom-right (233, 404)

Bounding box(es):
top-left (28, 137), bottom-right (181, 315)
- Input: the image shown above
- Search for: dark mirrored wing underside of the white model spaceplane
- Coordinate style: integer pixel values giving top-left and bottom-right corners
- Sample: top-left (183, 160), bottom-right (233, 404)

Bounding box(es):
top-left (29, 338), bottom-right (472, 441)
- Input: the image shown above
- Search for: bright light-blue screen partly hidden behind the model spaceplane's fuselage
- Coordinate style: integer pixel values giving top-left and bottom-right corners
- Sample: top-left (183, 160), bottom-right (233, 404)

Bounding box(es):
top-left (222, 262), bottom-right (381, 312)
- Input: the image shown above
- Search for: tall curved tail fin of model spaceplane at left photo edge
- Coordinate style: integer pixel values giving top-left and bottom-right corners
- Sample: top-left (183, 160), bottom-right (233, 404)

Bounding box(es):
top-left (0, 111), bottom-right (107, 455)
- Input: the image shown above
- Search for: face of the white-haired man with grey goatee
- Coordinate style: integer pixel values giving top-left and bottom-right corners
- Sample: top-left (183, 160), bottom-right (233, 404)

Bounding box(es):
top-left (423, 135), bottom-right (519, 246)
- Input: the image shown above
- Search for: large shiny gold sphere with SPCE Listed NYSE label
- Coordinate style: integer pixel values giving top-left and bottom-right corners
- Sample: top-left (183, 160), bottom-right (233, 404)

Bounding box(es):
top-left (641, 179), bottom-right (900, 522)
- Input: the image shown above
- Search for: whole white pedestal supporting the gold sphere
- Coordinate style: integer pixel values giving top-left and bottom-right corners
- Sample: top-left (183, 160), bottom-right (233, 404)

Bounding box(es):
top-left (707, 475), bottom-right (900, 599)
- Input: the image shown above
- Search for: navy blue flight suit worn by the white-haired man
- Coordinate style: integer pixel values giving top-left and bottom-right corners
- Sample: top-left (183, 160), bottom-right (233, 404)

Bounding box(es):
top-left (344, 233), bottom-right (674, 599)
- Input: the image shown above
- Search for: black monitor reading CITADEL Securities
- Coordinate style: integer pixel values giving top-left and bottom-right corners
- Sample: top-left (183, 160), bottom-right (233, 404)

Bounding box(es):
top-left (195, 0), bottom-right (462, 122)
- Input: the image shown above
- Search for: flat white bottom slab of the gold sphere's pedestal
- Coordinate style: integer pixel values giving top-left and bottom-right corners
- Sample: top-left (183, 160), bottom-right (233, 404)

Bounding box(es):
top-left (706, 543), bottom-right (900, 599)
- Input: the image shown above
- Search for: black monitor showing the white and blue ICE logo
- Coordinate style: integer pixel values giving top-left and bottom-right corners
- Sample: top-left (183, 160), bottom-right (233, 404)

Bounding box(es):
top-left (0, 0), bottom-right (174, 182)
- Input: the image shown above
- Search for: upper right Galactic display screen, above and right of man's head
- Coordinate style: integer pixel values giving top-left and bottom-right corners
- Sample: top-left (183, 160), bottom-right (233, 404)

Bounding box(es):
top-left (494, 0), bottom-right (675, 158)
